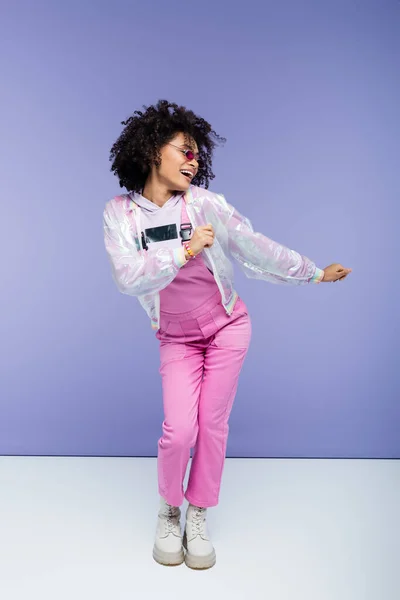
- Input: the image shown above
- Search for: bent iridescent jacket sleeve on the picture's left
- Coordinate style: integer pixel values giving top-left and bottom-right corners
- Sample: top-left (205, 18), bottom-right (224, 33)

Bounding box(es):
top-left (103, 200), bottom-right (186, 296)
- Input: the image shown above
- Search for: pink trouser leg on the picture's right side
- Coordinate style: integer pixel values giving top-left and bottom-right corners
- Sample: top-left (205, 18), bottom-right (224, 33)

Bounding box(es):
top-left (185, 303), bottom-right (251, 508)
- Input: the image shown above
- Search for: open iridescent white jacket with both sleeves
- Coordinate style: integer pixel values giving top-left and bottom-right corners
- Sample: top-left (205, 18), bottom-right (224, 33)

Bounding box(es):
top-left (103, 185), bottom-right (324, 329)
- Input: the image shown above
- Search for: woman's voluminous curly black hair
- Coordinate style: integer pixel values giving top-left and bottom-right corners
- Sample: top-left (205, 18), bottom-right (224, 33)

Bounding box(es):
top-left (109, 100), bottom-right (226, 192)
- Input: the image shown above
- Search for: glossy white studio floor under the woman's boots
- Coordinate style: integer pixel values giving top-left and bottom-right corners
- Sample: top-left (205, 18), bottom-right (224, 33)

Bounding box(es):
top-left (0, 457), bottom-right (400, 600)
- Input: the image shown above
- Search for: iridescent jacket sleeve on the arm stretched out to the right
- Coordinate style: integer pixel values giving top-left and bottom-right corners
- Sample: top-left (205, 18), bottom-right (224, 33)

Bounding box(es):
top-left (212, 195), bottom-right (324, 285)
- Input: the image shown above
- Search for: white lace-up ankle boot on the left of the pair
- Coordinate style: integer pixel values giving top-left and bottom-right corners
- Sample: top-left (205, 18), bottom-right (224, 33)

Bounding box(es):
top-left (153, 498), bottom-right (184, 566)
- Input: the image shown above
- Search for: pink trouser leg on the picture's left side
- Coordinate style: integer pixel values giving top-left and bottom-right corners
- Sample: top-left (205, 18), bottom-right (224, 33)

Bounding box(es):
top-left (157, 342), bottom-right (204, 506)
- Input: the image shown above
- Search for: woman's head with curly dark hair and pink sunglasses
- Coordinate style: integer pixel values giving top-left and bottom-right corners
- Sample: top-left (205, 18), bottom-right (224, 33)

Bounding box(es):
top-left (110, 100), bottom-right (226, 200)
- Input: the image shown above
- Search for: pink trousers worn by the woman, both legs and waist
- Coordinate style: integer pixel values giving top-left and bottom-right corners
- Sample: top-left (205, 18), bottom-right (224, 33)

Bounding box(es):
top-left (157, 292), bottom-right (251, 507)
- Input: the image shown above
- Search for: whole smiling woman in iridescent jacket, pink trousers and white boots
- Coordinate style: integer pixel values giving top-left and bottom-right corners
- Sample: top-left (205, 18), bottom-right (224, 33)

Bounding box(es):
top-left (104, 100), bottom-right (351, 569)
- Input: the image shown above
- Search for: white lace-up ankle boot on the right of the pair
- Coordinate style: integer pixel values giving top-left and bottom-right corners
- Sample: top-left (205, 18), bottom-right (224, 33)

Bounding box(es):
top-left (183, 504), bottom-right (216, 569)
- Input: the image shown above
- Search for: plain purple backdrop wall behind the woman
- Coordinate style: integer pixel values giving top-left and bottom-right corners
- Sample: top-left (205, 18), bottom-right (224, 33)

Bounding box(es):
top-left (0, 0), bottom-right (400, 458)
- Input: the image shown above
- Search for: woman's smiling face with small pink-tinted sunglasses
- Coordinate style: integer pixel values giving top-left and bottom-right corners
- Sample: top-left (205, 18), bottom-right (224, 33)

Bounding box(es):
top-left (152, 133), bottom-right (199, 192)
